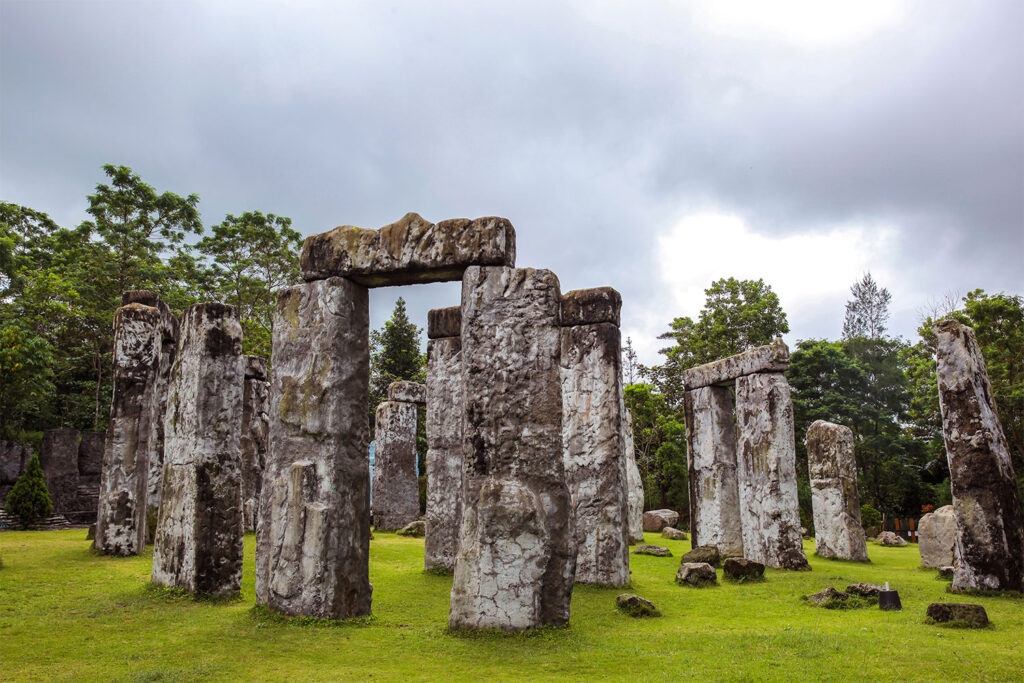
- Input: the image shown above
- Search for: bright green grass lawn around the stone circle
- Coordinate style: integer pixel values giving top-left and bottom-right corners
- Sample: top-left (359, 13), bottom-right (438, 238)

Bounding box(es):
top-left (0, 529), bottom-right (1024, 682)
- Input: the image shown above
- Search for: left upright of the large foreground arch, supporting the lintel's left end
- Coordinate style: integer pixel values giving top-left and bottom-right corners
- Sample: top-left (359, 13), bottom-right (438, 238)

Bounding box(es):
top-left (256, 278), bottom-right (373, 618)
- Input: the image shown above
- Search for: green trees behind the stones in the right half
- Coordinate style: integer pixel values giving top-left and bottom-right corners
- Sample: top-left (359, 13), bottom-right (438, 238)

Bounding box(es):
top-left (624, 273), bottom-right (1024, 520)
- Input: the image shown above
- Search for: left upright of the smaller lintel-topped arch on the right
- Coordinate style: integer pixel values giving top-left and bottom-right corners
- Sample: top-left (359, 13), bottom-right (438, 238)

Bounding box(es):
top-left (683, 386), bottom-right (743, 555)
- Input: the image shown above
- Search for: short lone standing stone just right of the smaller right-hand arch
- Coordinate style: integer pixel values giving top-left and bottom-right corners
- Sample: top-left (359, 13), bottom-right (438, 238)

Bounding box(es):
top-left (806, 420), bottom-right (867, 562)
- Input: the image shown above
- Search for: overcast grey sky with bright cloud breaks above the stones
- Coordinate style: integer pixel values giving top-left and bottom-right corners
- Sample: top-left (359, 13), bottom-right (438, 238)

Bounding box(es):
top-left (0, 0), bottom-right (1024, 362)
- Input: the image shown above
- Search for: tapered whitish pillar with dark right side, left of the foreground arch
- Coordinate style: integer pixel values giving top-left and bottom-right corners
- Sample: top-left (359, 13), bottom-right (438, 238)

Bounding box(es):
top-left (153, 303), bottom-right (244, 595)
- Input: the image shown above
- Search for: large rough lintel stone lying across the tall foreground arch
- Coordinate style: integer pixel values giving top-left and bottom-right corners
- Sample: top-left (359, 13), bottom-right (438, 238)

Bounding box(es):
top-left (300, 213), bottom-right (515, 287)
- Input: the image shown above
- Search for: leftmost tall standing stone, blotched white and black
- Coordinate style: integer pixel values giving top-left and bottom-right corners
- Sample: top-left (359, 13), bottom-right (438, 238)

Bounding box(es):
top-left (95, 303), bottom-right (161, 555)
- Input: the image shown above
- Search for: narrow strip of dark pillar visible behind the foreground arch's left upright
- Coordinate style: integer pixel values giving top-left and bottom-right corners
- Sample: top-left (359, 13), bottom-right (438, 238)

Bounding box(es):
top-left (242, 355), bottom-right (270, 531)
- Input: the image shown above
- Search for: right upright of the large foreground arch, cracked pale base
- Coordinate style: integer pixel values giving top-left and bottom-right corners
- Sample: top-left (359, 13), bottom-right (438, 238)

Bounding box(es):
top-left (449, 266), bottom-right (577, 631)
